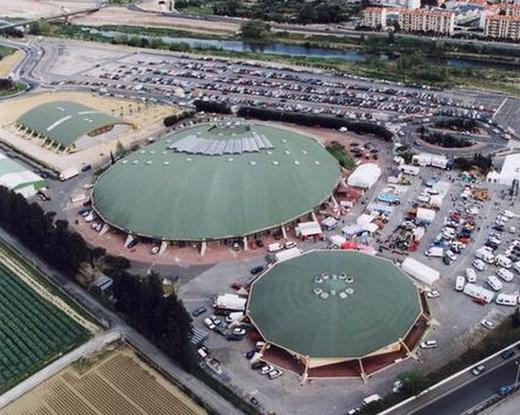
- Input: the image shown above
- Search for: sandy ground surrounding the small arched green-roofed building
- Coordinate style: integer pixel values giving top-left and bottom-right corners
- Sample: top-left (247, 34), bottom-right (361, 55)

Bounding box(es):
top-left (0, 92), bottom-right (174, 172)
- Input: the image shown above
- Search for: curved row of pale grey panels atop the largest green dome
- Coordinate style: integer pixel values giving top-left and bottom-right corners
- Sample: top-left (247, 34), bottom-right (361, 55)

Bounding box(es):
top-left (168, 132), bottom-right (274, 156)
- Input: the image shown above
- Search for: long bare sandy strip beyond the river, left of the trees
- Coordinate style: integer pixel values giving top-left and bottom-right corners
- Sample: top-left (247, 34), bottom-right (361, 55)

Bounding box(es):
top-left (72, 7), bottom-right (240, 34)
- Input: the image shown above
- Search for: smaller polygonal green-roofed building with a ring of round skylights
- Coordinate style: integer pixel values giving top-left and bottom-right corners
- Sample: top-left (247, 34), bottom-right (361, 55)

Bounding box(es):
top-left (247, 250), bottom-right (430, 380)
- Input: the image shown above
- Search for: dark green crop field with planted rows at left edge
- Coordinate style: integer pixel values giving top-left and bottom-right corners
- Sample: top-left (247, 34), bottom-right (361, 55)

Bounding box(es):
top-left (0, 264), bottom-right (88, 394)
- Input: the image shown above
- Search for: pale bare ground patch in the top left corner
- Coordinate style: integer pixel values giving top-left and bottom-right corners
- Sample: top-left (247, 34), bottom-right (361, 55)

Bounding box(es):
top-left (0, 0), bottom-right (96, 19)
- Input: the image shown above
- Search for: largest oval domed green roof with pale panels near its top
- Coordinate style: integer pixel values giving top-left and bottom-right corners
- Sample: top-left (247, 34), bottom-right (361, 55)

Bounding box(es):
top-left (92, 120), bottom-right (341, 241)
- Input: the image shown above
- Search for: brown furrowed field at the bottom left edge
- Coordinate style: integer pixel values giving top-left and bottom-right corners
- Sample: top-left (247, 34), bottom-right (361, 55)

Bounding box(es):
top-left (0, 348), bottom-right (206, 415)
